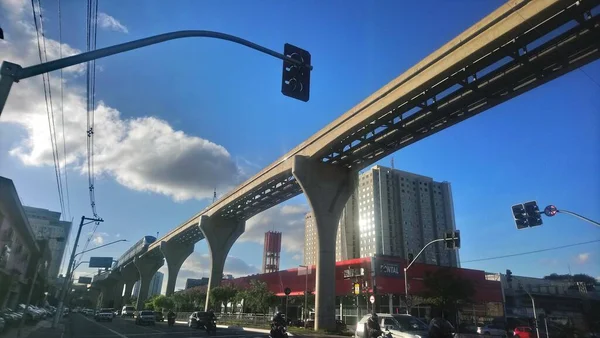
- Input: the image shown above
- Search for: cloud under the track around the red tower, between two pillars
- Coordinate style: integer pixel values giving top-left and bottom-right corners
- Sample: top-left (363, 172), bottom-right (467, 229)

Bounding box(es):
top-left (239, 204), bottom-right (309, 254)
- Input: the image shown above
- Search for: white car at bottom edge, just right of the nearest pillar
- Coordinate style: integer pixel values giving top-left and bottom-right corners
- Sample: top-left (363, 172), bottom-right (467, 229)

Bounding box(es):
top-left (354, 313), bottom-right (428, 338)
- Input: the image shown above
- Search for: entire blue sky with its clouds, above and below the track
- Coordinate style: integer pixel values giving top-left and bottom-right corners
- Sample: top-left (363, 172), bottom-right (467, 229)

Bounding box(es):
top-left (0, 0), bottom-right (600, 290)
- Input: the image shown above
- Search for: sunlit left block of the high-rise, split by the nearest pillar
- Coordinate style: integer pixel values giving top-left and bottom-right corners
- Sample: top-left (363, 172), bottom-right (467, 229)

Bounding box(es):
top-left (304, 187), bottom-right (360, 265)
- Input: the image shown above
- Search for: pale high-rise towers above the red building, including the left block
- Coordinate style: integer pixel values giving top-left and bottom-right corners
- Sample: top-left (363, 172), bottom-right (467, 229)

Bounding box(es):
top-left (304, 166), bottom-right (460, 267)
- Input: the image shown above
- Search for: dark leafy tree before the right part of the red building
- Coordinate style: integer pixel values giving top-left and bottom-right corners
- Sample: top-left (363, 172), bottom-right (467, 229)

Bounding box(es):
top-left (421, 269), bottom-right (475, 313)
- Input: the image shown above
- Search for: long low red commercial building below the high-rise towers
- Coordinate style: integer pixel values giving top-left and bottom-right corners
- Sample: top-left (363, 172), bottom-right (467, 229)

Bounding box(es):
top-left (224, 256), bottom-right (504, 324)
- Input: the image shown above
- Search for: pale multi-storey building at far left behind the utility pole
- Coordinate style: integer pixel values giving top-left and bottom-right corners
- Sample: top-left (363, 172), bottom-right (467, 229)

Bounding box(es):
top-left (23, 206), bottom-right (72, 278)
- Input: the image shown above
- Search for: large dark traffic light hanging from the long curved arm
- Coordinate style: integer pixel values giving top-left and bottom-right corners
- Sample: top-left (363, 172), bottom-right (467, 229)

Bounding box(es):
top-left (281, 43), bottom-right (310, 102)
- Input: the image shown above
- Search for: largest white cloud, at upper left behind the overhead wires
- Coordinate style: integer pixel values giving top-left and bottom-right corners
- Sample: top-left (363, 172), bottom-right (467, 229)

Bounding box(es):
top-left (0, 0), bottom-right (246, 201)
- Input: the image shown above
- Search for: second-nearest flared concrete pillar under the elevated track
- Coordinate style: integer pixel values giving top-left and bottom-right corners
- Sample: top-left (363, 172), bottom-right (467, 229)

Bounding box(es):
top-left (199, 215), bottom-right (246, 311)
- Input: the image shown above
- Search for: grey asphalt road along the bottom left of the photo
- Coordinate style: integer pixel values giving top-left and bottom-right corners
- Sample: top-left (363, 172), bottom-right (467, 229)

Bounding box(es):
top-left (62, 313), bottom-right (268, 338)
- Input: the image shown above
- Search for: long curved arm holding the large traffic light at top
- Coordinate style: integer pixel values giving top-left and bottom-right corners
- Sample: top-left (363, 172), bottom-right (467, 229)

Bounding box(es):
top-left (0, 30), bottom-right (313, 115)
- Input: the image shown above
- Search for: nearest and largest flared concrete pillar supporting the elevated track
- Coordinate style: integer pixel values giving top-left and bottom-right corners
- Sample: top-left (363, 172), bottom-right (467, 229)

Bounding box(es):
top-left (292, 156), bottom-right (356, 330)
